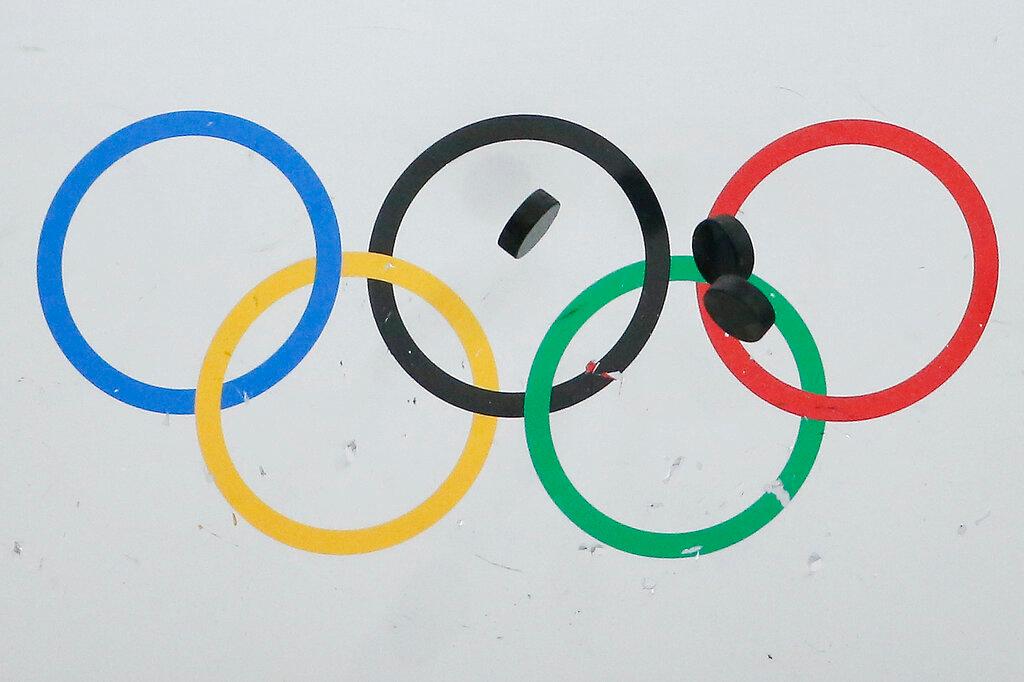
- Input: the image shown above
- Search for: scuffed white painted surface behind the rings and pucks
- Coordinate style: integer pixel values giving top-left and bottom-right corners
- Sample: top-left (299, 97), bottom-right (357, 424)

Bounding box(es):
top-left (0, 0), bottom-right (1024, 680)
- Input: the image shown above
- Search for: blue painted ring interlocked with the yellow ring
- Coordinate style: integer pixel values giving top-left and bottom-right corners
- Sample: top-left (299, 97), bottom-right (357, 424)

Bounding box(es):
top-left (36, 112), bottom-right (341, 415)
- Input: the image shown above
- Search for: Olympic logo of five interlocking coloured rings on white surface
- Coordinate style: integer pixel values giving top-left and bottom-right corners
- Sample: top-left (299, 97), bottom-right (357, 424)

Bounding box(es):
top-left (37, 111), bottom-right (998, 558)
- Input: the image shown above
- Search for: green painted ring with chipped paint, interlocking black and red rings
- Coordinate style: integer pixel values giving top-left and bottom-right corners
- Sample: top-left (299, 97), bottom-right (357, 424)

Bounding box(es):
top-left (523, 256), bottom-right (825, 558)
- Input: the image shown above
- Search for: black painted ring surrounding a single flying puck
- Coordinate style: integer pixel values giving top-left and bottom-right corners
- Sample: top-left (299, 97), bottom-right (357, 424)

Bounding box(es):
top-left (368, 114), bottom-right (672, 417)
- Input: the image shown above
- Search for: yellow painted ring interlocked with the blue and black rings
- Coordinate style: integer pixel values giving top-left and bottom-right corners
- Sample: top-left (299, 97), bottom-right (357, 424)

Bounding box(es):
top-left (196, 252), bottom-right (498, 554)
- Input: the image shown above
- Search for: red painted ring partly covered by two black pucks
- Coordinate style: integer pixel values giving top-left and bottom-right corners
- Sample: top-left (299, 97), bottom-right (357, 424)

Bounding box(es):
top-left (697, 120), bottom-right (999, 422)
